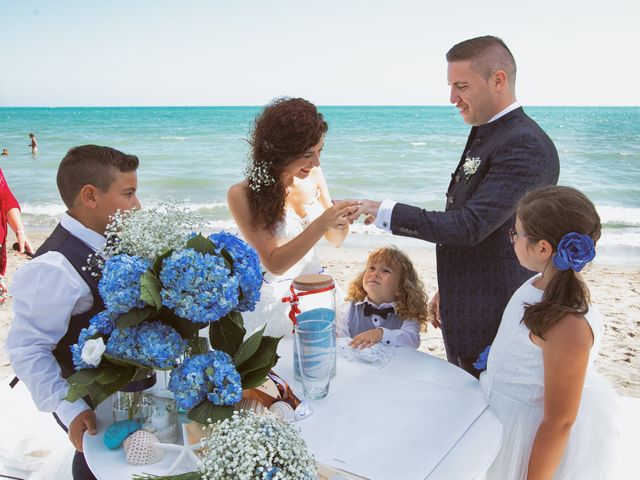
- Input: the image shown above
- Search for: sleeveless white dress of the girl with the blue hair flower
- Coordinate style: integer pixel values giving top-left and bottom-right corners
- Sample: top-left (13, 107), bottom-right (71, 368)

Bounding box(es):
top-left (480, 275), bottom-right (617, 480)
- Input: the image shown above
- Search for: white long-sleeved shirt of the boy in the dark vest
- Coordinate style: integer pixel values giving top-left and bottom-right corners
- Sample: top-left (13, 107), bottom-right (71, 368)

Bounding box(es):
top-left (6, 213), bottom-right (105, 427)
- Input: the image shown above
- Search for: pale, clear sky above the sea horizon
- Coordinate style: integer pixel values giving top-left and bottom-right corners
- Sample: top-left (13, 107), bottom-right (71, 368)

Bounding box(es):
top-left (0, 0), bottom-right (640, 107)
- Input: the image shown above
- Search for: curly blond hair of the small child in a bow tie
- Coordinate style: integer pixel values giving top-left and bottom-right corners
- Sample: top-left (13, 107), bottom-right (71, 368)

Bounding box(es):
top-left (346, 245), bottom-right (429, 330)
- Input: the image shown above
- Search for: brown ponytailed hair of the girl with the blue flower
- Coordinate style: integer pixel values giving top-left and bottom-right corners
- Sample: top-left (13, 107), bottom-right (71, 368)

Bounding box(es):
top-left (517, 186), bottom-right (602, 339)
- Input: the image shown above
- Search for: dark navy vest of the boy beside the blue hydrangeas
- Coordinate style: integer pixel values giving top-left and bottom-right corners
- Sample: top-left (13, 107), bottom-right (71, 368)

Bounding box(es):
top-left (34, 224), bottom-right (105, 378)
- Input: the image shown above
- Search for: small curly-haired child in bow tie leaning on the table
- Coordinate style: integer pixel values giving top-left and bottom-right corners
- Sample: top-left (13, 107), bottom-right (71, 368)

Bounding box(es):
top-left (336, 246), bottom-right (429, 349)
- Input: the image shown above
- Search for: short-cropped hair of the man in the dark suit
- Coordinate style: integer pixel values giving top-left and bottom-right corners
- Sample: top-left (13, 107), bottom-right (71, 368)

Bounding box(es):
top-left (447, 35), bottom-right (516, 86)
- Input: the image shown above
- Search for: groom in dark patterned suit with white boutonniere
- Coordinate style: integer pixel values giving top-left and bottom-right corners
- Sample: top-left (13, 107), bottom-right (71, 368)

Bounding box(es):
top-left (350, 36), bottom-right (559, 377)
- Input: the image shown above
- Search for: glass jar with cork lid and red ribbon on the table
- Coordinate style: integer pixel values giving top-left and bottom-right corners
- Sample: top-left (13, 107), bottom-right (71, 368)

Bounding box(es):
top-left (282, 273), bottom-right (336, 381)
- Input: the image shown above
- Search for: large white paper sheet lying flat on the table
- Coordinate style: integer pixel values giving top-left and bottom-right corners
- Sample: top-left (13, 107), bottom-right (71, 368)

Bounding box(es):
top-left (297, 370), bottom-right (487, 480)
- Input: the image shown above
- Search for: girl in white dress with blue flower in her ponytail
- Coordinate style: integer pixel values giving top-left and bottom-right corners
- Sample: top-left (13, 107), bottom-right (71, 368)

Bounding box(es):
top-left (480, 186), bottom-right (616, 480)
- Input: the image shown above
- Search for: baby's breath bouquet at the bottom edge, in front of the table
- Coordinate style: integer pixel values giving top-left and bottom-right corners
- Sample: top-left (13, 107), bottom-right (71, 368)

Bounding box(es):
top-left (201, 410), bottom-right (318, 480)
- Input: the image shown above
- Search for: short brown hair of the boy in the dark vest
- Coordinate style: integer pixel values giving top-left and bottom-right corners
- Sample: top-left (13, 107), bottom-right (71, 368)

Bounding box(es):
top-left (56, 145), bottom-right (139, 208)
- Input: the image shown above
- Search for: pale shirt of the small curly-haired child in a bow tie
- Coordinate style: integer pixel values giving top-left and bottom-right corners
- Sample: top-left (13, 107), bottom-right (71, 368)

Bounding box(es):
top-left (336, 297), bottom-right (420, 348)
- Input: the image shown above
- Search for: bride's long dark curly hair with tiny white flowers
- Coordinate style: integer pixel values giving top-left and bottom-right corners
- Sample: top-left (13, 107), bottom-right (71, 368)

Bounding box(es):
top-left (247, 97), bottom-right (329, 232)
